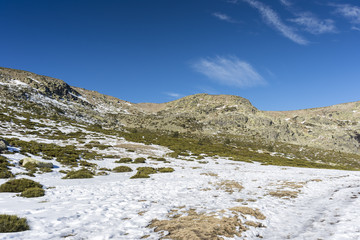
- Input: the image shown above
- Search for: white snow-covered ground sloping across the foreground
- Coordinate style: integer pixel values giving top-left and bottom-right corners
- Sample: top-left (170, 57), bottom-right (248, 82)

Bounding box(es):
top-left (0, 115), bottom-right (360, 240)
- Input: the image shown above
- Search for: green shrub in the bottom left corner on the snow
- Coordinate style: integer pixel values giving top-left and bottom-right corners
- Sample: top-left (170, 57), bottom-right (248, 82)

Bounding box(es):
top-left (0, 214), bottom-right (30, 233)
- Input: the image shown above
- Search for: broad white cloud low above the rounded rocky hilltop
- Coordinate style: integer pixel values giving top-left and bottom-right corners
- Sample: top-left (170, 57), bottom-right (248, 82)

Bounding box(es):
top-left (193, 56), bottom-right (266, 88)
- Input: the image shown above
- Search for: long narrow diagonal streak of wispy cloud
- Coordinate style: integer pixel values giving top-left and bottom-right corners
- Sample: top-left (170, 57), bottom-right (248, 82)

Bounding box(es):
top-left (243, 0), bottom-right (308, 45)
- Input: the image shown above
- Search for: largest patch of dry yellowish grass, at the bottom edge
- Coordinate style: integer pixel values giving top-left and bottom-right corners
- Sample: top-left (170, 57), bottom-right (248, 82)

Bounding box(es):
top-left (149, 211), bottom-right (247, 240)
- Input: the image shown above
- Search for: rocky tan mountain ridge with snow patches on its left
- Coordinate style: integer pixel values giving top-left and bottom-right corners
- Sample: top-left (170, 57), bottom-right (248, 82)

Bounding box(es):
top-left (0, 68), bottom-right (360, 154)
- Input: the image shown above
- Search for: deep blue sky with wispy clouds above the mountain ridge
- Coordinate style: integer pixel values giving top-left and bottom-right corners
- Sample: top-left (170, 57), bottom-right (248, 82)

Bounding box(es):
top-left (0, 0), bottom-right (360, 110)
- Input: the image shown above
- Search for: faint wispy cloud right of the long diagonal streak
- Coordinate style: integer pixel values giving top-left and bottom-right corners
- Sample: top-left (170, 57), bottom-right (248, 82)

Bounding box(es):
top-left (290, 13), bottom-right (336, 34)
